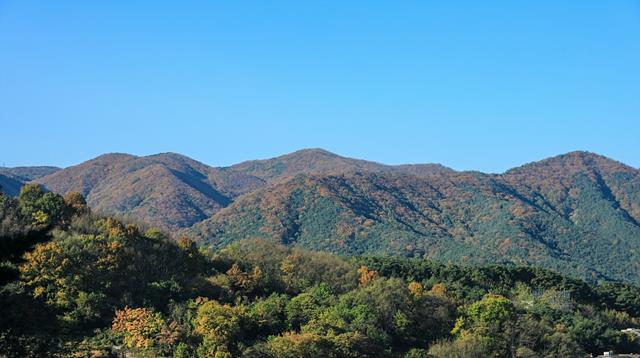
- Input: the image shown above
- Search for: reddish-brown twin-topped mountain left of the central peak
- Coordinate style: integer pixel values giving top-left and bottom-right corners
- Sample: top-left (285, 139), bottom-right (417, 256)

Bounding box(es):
top-left (36, 153), bottom-right (263, 229)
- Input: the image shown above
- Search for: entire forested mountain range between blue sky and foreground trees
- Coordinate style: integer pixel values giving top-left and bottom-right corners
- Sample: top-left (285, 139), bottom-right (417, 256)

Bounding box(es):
top-left (0, 149), bottom-right (640, 283)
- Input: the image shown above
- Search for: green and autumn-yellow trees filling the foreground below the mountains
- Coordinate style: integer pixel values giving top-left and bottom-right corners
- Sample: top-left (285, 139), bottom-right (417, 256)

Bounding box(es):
top-left (0, 185), bottom-right (640, 357)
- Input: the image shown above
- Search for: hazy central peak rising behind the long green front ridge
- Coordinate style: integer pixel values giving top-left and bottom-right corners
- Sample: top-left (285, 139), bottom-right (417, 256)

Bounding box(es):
top-left (230, 149), bottom-right (453, 182)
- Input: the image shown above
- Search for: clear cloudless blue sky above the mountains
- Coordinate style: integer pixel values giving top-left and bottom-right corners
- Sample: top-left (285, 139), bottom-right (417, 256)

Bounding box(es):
top-left (0, 0), bottom-right (640, 172)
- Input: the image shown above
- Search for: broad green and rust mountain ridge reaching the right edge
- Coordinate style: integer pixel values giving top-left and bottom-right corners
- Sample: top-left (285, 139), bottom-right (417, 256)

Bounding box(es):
top-left (188, 152), bottom-right (640, 283)
